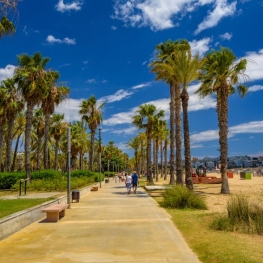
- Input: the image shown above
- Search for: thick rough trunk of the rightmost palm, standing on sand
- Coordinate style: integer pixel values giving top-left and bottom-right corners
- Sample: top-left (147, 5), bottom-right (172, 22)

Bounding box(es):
top-left (218, 83), bottom-right (230, 194)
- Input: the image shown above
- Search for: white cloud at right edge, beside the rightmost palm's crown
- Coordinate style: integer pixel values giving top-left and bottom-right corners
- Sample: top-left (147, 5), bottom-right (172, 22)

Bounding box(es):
top-left (243, 49), bottom-right (263, 81)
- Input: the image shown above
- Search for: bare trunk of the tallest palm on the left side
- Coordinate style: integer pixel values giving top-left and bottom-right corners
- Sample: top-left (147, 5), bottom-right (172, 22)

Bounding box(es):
top-left (25, 101), bottom-right (34, 182)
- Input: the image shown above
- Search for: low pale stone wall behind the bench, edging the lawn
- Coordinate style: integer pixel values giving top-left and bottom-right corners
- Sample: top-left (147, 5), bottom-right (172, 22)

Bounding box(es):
top-left (0, 186), bottom-right (97, 240)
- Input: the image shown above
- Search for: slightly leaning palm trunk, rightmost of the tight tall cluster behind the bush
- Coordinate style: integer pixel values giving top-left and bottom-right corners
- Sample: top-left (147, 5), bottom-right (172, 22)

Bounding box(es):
top-left (181, 88), bottom-right (194, 190)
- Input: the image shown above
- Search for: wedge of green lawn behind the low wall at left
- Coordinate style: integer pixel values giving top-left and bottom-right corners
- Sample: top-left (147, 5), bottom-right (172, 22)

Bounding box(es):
top-left (0, 198), bottom-right (52, 218)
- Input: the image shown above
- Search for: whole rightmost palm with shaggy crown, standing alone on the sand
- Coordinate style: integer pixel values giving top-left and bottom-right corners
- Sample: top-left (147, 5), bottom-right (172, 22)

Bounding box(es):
top-left (197, 47), bottom-right (248, 194)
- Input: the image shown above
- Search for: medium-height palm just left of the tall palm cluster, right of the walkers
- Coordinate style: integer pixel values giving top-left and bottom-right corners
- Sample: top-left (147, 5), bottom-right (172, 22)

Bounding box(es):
top-left (132, 104), bottom-right (164, 184)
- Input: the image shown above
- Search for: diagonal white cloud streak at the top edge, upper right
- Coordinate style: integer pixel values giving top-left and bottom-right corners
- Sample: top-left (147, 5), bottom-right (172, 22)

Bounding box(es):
top-left (195, 0), bottom-right (237, 34)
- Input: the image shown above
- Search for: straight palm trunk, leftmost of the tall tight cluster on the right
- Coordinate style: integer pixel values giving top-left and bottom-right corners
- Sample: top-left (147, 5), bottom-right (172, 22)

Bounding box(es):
top-left (170, 83), bottom-right (175, 184)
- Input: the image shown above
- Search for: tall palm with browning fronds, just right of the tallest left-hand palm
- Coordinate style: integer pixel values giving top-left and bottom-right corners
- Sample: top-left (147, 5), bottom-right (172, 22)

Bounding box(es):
top-left (41, 81), bottom-right (70, 169)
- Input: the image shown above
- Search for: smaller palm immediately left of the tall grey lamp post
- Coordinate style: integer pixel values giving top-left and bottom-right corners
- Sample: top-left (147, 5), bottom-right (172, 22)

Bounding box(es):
top-left (50, 113), bottom-right (68, 170)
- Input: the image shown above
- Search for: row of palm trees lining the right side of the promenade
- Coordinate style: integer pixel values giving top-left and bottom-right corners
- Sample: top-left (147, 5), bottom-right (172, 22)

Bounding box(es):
top-left (129, 40), bottom-right (248, 194)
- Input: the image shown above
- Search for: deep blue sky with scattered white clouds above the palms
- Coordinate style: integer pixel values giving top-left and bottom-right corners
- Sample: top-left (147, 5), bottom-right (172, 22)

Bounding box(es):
top-left (0, 0), bottom-right (263, 157)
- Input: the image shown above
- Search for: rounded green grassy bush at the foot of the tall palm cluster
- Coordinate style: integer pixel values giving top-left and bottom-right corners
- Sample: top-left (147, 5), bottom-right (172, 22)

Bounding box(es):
top-left (161, 186), bottom-right (207, 209)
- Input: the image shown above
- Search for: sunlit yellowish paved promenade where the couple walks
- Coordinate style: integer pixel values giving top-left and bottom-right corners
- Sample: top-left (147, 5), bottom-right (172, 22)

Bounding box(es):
top-left (0, 180), bottom-right (199, 263)
